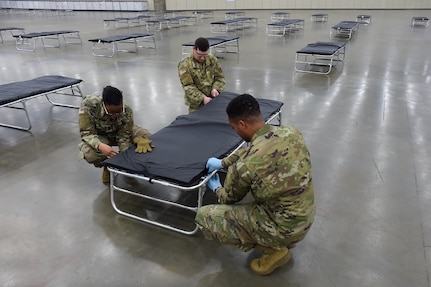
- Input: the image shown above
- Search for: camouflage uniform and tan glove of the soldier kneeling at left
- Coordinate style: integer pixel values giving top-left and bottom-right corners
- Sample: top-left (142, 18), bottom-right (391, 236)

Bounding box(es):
top-left (78, 95), bottom-right (151, 166)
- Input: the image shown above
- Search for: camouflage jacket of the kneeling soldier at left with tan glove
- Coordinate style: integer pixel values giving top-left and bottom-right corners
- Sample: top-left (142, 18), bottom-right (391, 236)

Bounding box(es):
top-left (79, 95), bottom-right (134, 151)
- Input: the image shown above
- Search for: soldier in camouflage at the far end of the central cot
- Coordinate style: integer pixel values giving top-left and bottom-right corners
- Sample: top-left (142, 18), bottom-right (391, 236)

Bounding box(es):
top-left (178, 38), bottom-right (226, 113)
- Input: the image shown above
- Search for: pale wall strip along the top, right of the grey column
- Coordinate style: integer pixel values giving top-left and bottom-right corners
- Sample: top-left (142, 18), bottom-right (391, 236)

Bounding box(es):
top-left (166, 0), bottom-right (431, 10)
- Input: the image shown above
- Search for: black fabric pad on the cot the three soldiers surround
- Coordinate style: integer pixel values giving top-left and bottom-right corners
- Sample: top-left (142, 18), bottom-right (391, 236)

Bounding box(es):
top-left (104, 92), bottom-right (283, 186)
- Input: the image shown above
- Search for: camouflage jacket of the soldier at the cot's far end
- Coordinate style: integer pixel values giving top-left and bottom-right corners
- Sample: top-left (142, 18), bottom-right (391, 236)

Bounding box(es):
top-left (178, 53), bottom-right (226, 110)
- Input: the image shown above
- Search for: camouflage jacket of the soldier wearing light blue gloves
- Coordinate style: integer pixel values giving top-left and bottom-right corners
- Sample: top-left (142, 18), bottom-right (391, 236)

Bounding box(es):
top-left (217, 125), bottom-right (315, 237)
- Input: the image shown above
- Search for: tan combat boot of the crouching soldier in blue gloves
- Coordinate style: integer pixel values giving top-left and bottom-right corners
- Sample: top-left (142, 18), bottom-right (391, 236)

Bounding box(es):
top-left (250, 246), bottom-right (292, 275)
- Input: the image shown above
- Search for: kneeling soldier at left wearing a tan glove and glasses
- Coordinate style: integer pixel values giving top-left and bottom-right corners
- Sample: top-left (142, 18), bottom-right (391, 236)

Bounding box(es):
top-left (78, 86), bottom-right (153, 183)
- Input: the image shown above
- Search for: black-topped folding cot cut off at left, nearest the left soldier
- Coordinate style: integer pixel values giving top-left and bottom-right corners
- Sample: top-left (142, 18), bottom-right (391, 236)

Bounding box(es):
top-left (0, 76), bottom-right (83, 131)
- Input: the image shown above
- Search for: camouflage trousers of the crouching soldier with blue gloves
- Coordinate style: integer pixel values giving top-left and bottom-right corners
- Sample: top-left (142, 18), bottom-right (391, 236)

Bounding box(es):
top-left (195, 202), bottom-right (308, 251)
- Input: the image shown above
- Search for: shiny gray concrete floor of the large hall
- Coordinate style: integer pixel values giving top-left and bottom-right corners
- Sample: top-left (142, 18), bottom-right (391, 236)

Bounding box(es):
top-left (0, 7), bottom-right (431, 287)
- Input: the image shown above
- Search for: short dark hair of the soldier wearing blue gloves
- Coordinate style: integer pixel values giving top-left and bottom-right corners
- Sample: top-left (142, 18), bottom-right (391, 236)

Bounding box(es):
top-left (226, 94), bottom-right (261, 120)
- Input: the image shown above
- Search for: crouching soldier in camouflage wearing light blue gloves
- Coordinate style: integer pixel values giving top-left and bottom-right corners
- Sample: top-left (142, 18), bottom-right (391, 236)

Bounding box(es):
top-left (196, 95), bottom-right (315, 275)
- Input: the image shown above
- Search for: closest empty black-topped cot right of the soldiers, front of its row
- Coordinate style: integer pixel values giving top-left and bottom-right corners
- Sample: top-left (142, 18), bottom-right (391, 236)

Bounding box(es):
top-left (295, 42), bottom-right (346, 74)
